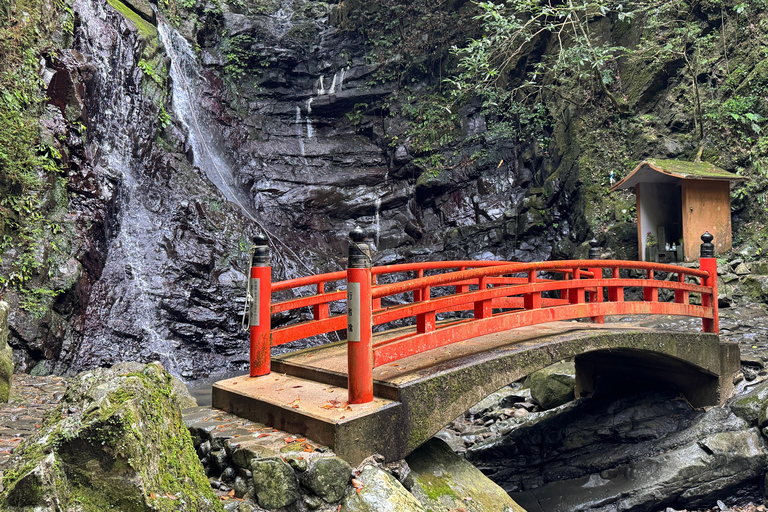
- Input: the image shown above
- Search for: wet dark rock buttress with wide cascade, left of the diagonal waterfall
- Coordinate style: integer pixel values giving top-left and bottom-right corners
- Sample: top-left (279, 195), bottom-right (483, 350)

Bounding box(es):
top-left (18, 0), bottom-right (253, 377)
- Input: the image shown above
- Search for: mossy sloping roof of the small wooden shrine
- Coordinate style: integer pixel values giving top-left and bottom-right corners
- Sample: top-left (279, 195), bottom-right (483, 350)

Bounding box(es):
top-left (611, 160), bottom-right (746, 192)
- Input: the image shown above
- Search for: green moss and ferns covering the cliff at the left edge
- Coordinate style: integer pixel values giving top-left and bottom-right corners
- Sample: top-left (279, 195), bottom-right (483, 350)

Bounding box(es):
top-left (0, 0), bottom-right (73, 315)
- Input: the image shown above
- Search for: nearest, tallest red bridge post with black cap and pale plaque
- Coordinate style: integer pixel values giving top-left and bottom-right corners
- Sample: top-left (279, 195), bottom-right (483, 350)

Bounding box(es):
top-left (347, 228), bottom-right (373, 404)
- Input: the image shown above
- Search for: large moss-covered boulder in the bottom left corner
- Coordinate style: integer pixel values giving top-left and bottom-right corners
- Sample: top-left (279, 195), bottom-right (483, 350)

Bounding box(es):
top-left (0, 363), bottom-right (223, 512)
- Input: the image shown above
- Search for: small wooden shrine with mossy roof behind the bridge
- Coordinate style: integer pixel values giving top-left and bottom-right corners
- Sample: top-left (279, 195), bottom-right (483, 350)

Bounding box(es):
top-left (611, 160), bottom-right (745, 263)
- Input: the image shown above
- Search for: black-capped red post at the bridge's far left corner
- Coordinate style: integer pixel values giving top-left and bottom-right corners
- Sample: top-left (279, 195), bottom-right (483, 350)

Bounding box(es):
top-left (248, 233), bottom-right (272, 377)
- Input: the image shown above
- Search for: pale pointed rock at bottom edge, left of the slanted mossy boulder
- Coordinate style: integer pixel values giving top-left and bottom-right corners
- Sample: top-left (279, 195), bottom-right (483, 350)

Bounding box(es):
top-left (341, 466), bottom-right (427, 512)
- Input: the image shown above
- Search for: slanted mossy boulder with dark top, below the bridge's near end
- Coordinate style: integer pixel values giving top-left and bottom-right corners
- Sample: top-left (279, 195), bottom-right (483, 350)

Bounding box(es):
top-left (406, 438), bottom-right (525, 512)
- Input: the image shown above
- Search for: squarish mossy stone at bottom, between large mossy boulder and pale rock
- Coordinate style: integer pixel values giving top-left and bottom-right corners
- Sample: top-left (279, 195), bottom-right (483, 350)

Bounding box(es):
top-left (251, 457), bottom-right (299, 510)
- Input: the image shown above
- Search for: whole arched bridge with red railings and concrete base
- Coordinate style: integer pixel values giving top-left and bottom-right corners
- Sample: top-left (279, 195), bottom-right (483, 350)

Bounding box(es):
top-left (213, 230), bottom-right (739, 462)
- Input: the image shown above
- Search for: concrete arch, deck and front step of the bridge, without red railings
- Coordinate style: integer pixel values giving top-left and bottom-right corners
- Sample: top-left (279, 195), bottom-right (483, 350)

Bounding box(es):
top-left (213, 322), bottom-right (740, 464)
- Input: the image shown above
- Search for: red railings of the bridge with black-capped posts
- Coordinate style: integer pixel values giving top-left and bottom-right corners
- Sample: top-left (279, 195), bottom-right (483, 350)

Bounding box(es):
top-left (249, 231), bottom-right (718, 403)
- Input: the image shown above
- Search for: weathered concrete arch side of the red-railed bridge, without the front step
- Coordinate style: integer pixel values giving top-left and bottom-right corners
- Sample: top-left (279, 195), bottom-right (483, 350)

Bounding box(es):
top-left (336, 322), bottom-right (740, 460)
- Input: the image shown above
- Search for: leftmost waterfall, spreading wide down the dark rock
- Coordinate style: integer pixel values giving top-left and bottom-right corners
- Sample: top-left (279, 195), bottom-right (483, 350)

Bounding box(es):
top-left (67, 0), bottom-right (182, 375)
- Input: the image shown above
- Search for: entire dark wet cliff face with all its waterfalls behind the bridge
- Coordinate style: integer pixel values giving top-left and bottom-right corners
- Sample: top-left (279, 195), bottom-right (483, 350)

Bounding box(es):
top-left (12, 0), bottom-right (582, 378)
